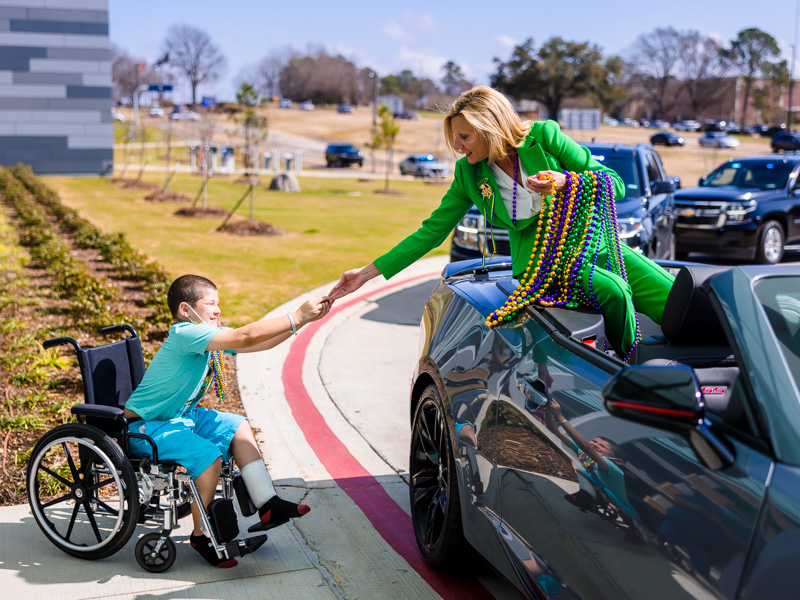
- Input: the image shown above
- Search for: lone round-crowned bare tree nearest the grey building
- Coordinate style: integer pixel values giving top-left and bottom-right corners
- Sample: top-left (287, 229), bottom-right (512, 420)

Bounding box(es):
top-left (164, 25), bottom-right (225, 104)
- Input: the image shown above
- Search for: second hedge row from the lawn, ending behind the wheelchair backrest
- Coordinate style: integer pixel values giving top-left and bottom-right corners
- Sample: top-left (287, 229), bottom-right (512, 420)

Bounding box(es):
top-left (0, 168), bottom-right (128, 330)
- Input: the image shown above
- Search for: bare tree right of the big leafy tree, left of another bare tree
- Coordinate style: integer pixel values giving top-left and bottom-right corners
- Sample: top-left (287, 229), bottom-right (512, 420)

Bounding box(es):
top-left (628, 27), bottom-right (683, 119)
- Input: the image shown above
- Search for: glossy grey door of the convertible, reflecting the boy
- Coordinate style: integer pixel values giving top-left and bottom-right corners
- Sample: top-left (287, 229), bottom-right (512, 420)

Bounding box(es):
top-left (495, 318), bottom-right (772, 600)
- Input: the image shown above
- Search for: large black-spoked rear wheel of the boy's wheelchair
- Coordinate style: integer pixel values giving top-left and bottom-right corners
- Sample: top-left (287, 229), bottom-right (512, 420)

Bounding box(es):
top-left (26, 424), bottom-right (139, 560)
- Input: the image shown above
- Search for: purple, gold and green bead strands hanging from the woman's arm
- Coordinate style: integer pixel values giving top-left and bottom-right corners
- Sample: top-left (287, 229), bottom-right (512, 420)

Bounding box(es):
top-left (486, 171), bottom-right (640, 336)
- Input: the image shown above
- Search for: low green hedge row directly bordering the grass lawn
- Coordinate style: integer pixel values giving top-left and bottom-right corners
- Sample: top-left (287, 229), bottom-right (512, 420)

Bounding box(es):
top-left (11, 164), bottom-right (170, 328)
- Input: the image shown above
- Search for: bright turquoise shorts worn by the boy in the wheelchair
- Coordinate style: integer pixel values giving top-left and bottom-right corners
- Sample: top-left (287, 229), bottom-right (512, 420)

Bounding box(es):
top-left (128, 407), bottom-right (247, 477)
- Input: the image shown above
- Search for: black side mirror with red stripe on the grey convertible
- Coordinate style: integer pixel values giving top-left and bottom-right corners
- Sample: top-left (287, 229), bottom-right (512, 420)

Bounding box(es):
top-left (603, 365), bottom-right (735, 470)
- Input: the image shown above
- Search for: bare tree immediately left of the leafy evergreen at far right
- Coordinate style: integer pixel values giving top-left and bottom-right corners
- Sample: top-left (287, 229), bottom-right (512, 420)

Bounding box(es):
top-left (676, 31), bottom-right (730, 115)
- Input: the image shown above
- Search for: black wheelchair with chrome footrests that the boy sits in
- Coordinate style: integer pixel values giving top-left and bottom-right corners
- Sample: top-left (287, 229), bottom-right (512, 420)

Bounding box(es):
top-left (26, 324), bottom-right (267, 573)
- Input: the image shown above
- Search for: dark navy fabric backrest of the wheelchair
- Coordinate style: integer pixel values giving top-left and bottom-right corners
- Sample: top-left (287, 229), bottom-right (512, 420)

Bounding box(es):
top-left (77, 336), bottom-right (145, 407)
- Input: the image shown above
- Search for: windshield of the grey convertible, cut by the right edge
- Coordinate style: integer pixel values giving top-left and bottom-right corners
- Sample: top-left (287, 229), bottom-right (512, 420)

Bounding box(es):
top-left (754, 276), bottom-right (800, 386)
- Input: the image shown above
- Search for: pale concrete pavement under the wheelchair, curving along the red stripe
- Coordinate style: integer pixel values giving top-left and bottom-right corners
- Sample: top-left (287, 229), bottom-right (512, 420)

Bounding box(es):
top-left (0, 257), bottom-right (484, 600)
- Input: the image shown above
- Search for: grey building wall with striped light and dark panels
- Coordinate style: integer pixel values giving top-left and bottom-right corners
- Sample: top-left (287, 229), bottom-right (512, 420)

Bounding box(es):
top-left (0, 0), bottom-right (114, 175)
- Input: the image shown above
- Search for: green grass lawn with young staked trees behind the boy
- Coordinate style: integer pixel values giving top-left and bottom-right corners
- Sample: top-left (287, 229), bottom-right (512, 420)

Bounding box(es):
top-left (43, 173), bottom-right (449, 326)
